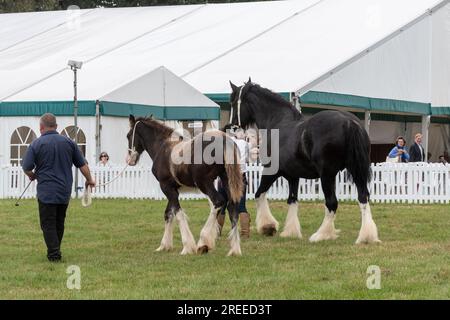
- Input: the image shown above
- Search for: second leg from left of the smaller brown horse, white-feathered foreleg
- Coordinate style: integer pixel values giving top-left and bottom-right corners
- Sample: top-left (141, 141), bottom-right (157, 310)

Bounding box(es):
top-left (161, 185), bottom-right (197, 255)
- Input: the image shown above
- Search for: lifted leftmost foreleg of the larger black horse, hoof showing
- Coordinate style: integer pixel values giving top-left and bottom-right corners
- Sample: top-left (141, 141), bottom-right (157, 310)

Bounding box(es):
top-left (255, 175), bottom-right (278, 236)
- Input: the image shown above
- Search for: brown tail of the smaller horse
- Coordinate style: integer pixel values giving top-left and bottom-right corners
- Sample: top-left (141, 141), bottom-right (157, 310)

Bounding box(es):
top-left (224, 138), bottom-right (244, 203)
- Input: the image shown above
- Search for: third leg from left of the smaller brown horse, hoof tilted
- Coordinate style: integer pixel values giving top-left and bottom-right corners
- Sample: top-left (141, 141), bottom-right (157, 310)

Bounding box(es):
top-left (197, 181), bottom-right (225, 253)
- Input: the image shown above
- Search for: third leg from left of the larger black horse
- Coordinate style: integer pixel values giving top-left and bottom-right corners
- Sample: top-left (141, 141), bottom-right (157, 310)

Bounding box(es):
top-left (309, 174), bottom-right (340, 242)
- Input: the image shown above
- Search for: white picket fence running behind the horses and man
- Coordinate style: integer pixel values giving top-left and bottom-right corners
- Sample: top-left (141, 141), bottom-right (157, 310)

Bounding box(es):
top-left (0, 163), bottom-right (450, 203)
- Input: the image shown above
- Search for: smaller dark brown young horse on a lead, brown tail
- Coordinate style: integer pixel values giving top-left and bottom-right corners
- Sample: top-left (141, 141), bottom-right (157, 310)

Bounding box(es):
top-left (127, 115), bottom-right (243, 255)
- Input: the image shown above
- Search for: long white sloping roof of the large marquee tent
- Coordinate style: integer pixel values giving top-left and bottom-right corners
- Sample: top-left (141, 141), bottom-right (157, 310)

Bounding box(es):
top-left (0, 0), bottom-right (448, 116)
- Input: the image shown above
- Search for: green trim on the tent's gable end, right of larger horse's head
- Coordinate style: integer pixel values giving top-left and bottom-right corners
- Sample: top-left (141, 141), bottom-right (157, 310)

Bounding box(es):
top-left (300, 91), bottom-right (431, 115)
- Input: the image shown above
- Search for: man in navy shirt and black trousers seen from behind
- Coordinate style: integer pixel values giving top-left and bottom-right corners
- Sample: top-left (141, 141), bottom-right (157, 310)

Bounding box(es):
top-left (22, 113), bottom-right (95, 261)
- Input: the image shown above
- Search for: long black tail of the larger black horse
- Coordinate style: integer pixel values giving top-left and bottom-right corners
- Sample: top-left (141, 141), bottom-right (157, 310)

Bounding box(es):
top-left (345, 120), bottom-right (372, 188)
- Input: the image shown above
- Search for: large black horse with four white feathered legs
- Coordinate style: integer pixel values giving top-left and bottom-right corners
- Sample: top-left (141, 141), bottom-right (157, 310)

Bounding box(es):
top-left (230, 80), bottom-right (380, 244)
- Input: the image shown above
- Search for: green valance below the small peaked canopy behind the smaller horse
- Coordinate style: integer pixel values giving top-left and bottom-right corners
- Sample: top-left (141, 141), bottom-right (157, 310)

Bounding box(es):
top-left (100, 101), bottom-right (220, 120)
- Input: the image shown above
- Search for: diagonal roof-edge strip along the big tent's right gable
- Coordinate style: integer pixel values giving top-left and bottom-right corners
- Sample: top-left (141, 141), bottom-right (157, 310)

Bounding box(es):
top-left (294, 0), bottom-right (450, 96)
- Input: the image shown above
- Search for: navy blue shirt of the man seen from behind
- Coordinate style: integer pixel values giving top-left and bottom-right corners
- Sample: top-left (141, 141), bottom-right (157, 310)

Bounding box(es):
top-left (22, 130), bottom-right (86, 204)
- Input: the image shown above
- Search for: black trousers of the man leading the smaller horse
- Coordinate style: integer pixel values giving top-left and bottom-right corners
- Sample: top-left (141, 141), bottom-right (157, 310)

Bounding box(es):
top-left (38, 201), bottom-right (68, 260)
